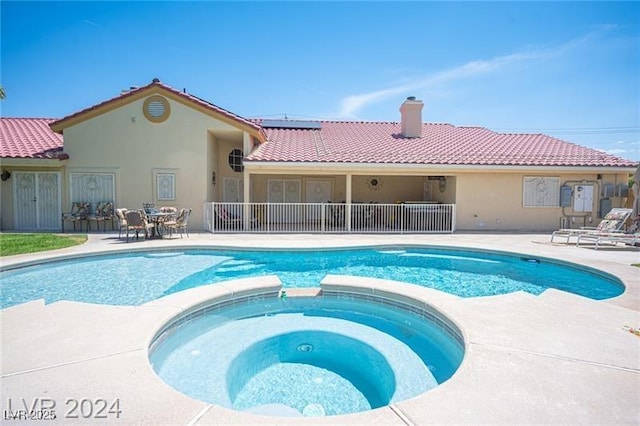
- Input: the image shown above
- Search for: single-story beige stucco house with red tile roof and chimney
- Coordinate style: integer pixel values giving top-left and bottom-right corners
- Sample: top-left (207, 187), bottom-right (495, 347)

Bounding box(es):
top-left (0, 79), bottom-right (636, 231)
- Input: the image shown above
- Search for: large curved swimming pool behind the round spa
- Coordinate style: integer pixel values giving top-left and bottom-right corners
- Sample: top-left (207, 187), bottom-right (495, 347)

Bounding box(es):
top-left (0, 246), bottom-right (624, 308)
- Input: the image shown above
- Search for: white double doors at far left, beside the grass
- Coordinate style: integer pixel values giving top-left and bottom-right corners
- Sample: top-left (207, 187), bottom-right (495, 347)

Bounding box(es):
top-left (13, 172), bottom-right (62, 231)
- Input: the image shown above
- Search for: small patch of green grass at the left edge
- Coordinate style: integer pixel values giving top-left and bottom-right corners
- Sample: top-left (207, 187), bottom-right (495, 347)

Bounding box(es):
top-left (0, 234), bottom-right (87, 256)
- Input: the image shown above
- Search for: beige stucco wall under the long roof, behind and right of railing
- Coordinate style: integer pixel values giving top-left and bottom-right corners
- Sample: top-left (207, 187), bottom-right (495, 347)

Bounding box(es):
top-left (245, 170), bottom-right (628, 232)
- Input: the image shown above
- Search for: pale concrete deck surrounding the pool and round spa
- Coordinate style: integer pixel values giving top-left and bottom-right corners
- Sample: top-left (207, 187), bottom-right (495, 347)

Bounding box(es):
top-left (0, 233), bottom-right (640, 425)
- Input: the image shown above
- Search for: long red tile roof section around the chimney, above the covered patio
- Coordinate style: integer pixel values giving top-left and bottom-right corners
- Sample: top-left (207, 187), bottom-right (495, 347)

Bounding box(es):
top-left (246, 120), bottom-right (636, 168)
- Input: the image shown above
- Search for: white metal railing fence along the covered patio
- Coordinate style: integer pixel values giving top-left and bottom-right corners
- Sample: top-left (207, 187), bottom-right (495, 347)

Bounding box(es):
top-left (204, 202), bottom-right (456, 233)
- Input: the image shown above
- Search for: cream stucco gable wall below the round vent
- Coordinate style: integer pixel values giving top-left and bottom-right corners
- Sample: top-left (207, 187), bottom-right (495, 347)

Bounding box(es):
top-left (63, 99), bottom-right (242, 229)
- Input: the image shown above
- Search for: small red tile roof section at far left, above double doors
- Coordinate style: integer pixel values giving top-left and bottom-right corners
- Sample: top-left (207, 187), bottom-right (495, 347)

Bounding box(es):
top-left (0, 117), bottom-right (62, 158)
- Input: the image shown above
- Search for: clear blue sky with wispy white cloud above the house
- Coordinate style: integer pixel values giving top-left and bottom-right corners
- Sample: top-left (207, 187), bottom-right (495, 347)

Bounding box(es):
top-left (0, 1), bottom-right (640, 160)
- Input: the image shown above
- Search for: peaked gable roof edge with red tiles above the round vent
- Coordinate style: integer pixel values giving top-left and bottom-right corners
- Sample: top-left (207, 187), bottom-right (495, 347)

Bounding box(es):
top-left (51, 78), bottom-right (261, 135)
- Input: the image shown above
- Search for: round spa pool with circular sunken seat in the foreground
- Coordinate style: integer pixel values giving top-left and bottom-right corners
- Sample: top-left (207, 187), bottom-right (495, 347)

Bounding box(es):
top-left (149, 297), bottom-right (464, 416)
